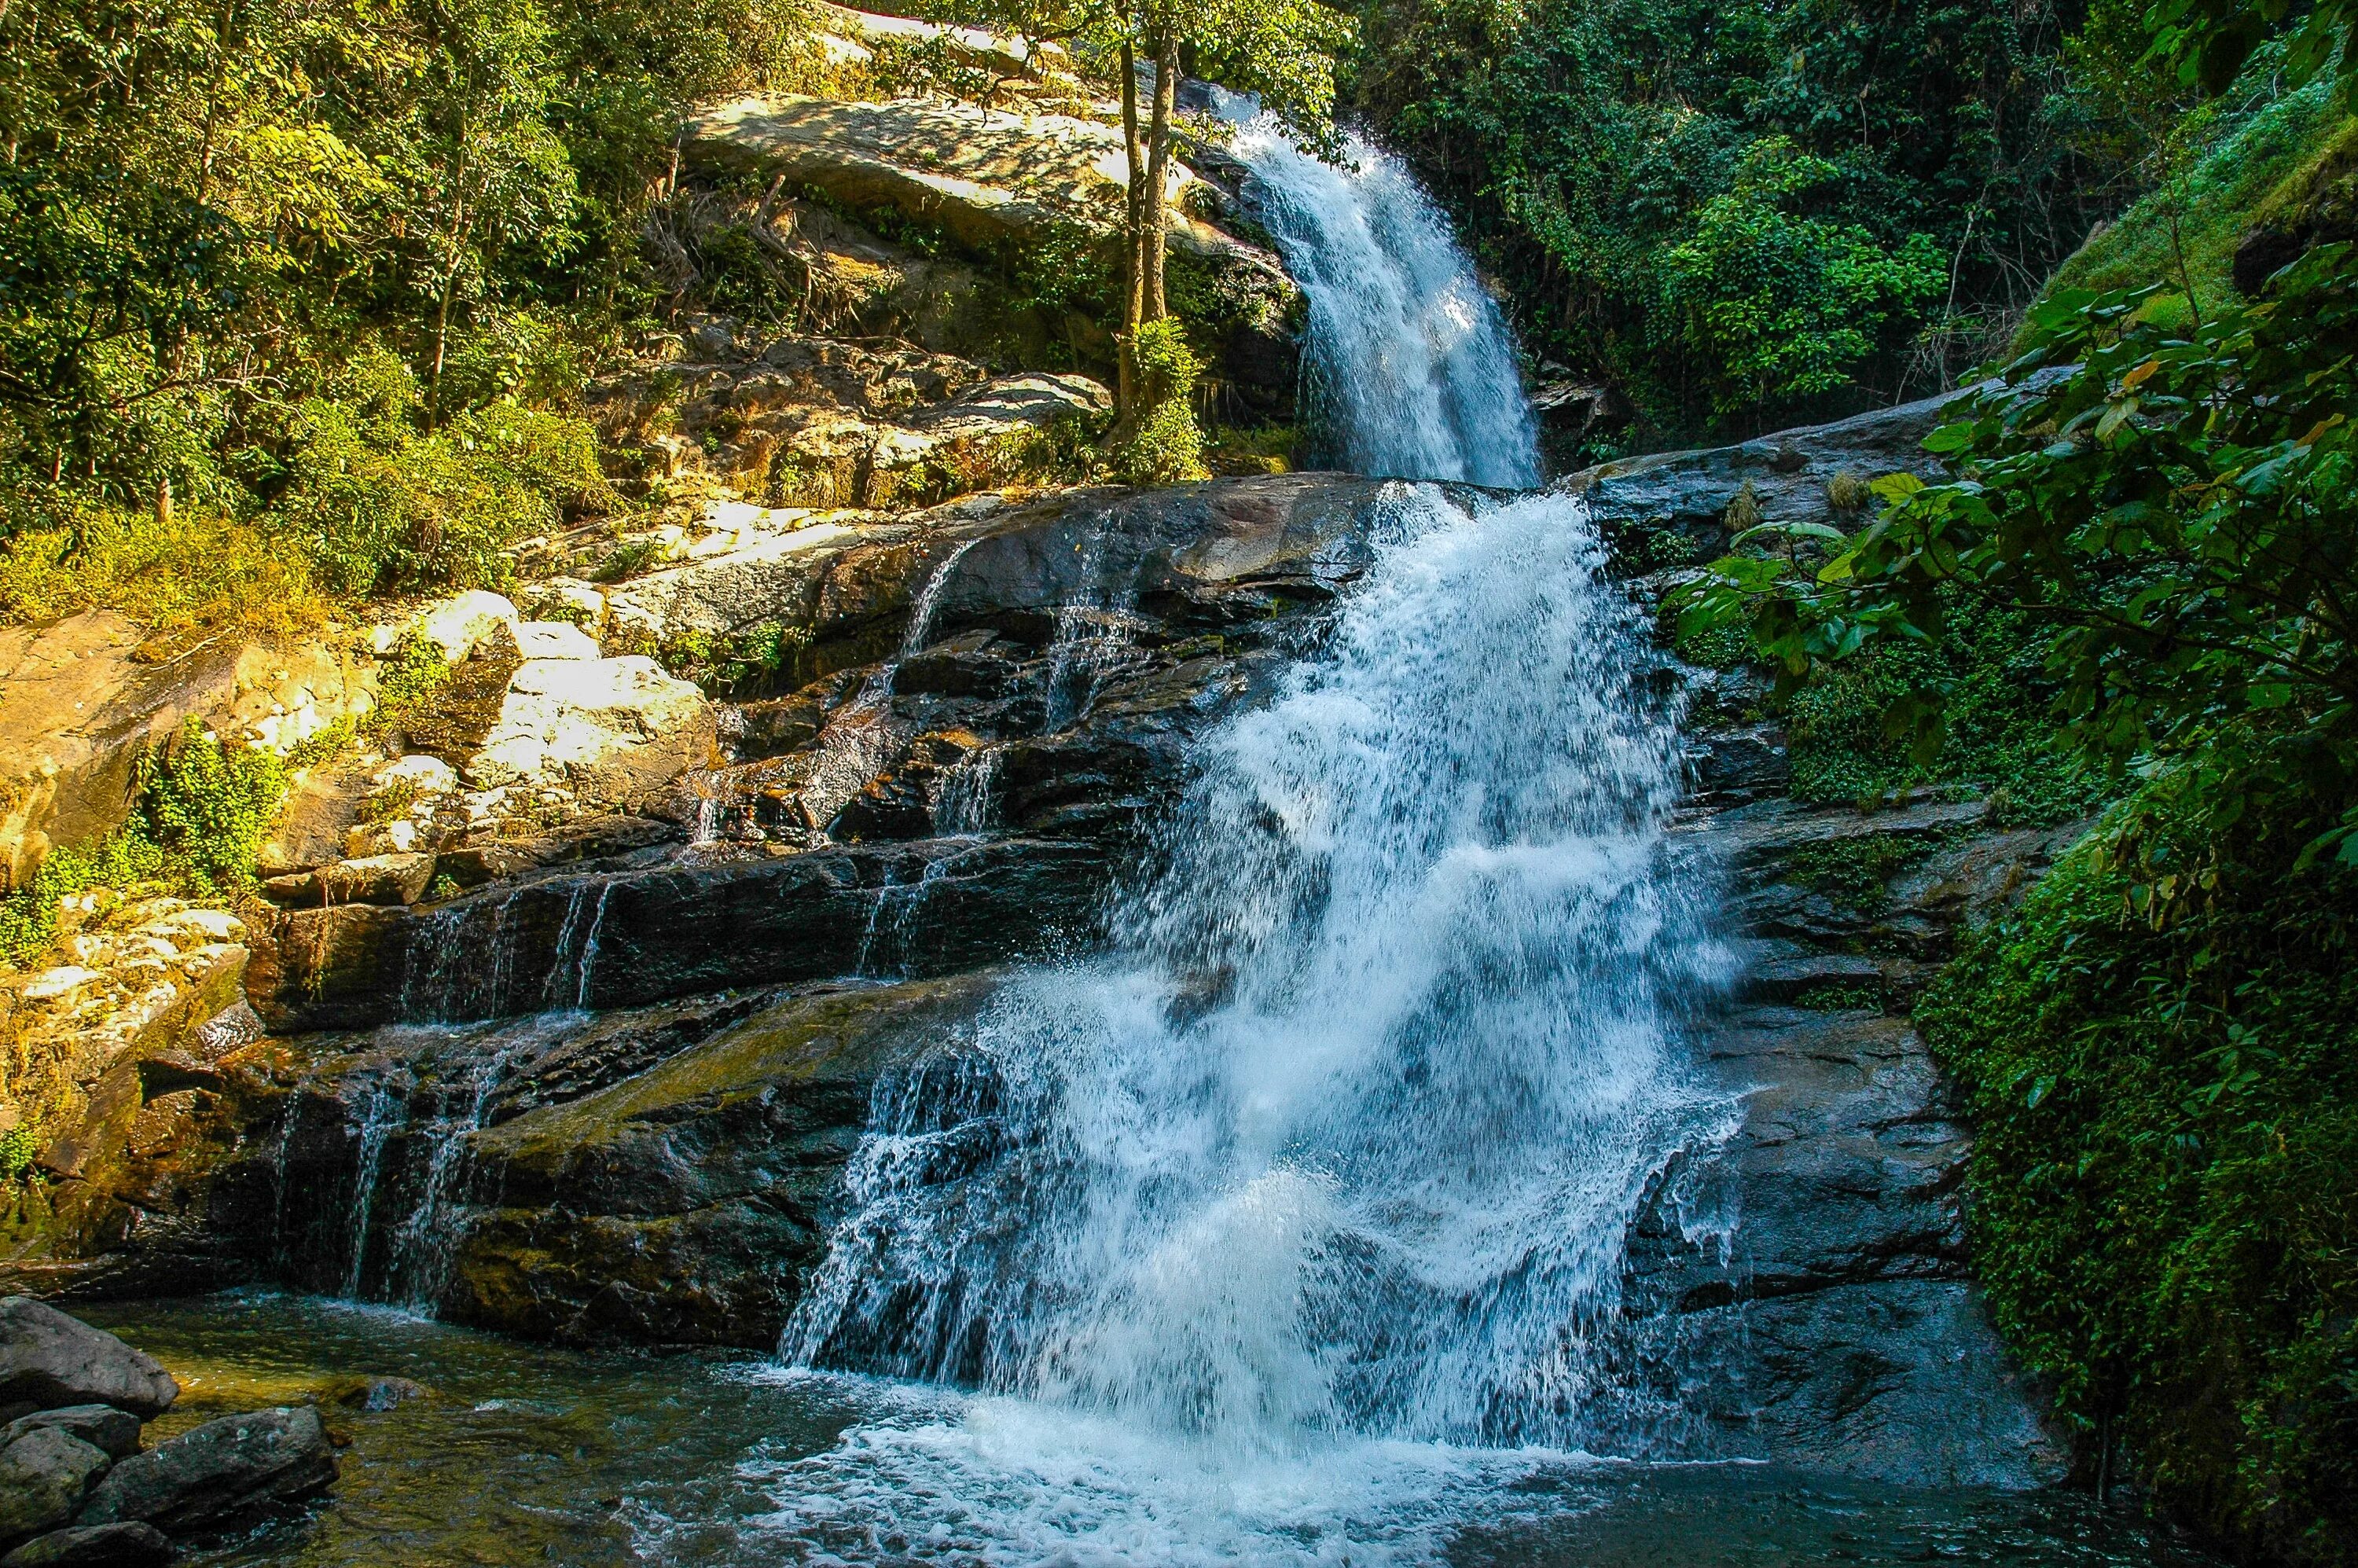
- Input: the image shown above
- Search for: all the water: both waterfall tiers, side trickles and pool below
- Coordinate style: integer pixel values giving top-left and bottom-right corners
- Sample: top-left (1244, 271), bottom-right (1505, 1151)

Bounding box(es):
top-left (166, 123), bottom-right (2207, 1568)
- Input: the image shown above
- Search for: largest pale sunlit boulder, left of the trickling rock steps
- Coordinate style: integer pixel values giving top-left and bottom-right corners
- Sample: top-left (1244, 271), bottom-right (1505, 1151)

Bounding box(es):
top-left (465, 655), bottom-right (714, 804)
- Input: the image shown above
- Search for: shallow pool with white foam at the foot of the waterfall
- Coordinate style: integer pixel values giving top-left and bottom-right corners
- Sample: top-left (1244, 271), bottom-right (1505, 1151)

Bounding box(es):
top-left (85, 1292), bottom-right (2207, 1568)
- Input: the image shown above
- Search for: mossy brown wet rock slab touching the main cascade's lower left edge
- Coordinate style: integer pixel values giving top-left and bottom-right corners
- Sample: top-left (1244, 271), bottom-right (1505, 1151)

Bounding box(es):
top-left (441, 974), bottom-right (995, 1349)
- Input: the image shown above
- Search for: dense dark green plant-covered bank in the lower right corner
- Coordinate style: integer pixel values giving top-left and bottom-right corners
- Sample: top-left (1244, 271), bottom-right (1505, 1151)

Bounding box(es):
top-left (1915, 802), bottom-right (2358, 1566)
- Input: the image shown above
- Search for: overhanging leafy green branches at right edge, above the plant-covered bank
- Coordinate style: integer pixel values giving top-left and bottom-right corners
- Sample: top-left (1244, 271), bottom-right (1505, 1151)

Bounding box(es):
top-left (1681, 245), bottom-right (2358, 858)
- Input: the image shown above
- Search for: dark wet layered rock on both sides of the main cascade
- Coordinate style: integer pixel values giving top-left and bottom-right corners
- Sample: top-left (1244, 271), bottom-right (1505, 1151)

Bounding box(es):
top-left (0, 389), bottom-right (2070, 1485)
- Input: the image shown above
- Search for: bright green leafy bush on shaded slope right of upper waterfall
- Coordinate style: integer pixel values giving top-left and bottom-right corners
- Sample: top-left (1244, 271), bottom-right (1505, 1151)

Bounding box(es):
top-left (1655, 137), bottom-right (1945, 413)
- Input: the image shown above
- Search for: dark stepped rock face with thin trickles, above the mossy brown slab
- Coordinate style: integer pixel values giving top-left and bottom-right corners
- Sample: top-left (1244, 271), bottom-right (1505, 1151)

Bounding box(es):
top-left (248, 474), bottom-right (1396, 1030)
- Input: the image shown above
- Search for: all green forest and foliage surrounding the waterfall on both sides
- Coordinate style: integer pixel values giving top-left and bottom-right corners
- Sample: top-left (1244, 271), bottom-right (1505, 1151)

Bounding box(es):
top-left (0, 0), bottom-right (2358, 1563)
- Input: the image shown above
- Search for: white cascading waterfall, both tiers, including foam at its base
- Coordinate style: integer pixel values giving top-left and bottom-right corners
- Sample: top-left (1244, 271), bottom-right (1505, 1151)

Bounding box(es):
top-left (755, 116), bottom-right (1731, 1561)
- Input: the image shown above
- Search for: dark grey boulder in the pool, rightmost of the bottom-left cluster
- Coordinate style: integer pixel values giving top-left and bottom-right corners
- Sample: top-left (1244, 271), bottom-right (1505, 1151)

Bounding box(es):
top-left (80, 1405), bottom-right (337, 1533)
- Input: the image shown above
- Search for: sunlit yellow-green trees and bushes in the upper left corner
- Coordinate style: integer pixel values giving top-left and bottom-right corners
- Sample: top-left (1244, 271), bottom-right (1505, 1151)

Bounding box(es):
top-left (0, 0), bottom-right (809, 564)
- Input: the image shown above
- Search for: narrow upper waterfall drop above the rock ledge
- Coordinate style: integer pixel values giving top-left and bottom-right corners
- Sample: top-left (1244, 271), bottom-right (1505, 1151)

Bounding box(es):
top-left (1217, 108), bottom-right (1540, 490)
